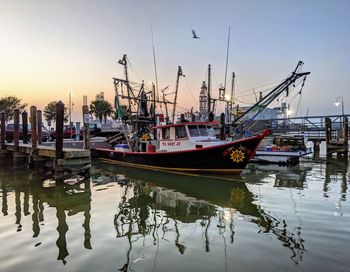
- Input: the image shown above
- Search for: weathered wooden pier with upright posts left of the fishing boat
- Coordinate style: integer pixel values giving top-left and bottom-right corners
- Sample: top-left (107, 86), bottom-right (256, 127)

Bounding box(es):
top-left (0, 101), bottom-right (91, 180)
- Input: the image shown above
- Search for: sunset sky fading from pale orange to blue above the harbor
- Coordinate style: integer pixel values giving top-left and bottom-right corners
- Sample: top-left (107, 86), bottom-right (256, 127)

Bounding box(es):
top-left (0, 0), bottom-right (350, 119)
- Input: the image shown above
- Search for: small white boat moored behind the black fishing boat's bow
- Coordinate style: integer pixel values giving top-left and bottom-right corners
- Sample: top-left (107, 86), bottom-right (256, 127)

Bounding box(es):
top-left (252, 135), bottom-right (312, 165)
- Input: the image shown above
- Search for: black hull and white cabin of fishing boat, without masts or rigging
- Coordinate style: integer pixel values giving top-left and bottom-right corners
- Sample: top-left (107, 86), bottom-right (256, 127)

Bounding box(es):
top-left (93, 122), bottom-right (270, 174)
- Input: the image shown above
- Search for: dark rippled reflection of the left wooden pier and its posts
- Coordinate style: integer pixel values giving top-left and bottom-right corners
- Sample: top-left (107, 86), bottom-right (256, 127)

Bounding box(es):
top-left (0, 169), bottom-right (92, 264)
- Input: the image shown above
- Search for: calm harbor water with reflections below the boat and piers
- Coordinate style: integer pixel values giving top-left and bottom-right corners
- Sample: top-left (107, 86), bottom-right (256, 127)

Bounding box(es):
top-left (0, 159), bottom-right (350, 272)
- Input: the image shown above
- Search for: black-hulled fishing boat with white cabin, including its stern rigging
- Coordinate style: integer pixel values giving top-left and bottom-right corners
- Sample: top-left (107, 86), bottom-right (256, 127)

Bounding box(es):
top-left (92, 55), bottom-right (269, 174)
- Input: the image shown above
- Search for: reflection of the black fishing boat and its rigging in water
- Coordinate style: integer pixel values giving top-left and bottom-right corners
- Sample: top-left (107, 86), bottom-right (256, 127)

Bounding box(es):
top-left (92, 164), bottom-right (305, 271)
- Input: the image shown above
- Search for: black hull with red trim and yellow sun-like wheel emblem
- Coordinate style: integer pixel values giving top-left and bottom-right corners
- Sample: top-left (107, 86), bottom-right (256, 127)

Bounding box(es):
top-left (93, 130), bottom-right (270, 174)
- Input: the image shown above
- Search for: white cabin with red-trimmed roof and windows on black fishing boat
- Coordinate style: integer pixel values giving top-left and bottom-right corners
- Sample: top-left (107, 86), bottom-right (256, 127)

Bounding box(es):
top-left (154, 122), bottom-right (224, 152)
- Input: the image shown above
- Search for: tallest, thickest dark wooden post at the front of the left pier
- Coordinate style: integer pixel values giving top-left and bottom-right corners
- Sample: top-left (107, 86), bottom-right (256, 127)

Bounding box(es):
top-left (55, 101), bottom-right (64, 180)
